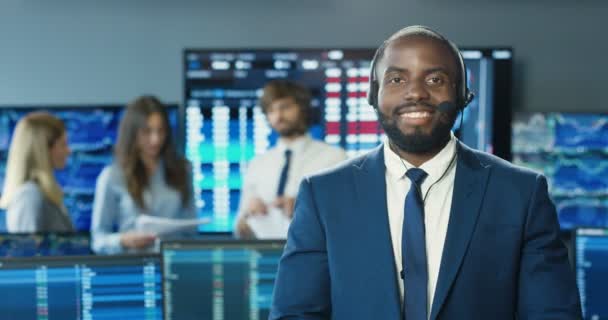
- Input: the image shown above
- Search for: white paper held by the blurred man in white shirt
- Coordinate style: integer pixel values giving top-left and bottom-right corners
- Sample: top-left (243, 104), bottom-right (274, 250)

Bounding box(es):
top-left (247, 208), bottom-right (291, 239)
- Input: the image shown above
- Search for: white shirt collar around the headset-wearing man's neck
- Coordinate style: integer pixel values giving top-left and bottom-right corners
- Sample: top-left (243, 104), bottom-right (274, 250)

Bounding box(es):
top-left (383, 133), bottom-right (457, 182)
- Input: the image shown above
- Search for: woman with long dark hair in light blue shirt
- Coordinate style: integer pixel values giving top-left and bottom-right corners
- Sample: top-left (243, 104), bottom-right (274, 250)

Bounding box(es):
top-left (91, 96), bottom-right (196, 254)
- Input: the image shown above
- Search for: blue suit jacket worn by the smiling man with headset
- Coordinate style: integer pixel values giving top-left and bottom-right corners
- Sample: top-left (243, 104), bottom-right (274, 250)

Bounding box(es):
top-left (270, 143), bottom-right (581, 320)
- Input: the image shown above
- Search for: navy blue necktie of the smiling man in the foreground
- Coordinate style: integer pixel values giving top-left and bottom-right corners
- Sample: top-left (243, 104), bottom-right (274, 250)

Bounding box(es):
top-left (401, 168), bottom-right (429, 320)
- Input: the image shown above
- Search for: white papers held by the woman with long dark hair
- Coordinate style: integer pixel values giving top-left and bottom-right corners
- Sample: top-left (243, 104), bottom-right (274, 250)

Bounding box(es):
top-left (135, 214), bottom-right (211, 237)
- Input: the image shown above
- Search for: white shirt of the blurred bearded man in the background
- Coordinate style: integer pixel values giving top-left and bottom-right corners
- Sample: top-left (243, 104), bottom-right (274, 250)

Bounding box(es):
top-left (237, 134), bottom-right (346, 232)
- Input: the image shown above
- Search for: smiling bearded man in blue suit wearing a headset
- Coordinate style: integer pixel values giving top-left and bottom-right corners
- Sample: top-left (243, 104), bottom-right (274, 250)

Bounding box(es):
top-left (270, 26), bottom-right (581, 320)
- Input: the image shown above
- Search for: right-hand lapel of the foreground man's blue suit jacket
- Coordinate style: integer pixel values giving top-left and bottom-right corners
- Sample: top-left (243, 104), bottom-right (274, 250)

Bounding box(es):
top-left (430, 142), bottom-right (490, 319)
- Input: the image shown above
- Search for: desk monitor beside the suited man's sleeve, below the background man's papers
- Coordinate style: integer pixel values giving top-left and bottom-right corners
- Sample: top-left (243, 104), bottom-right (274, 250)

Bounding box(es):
top-left (162, 241), bottom-right (284, 320)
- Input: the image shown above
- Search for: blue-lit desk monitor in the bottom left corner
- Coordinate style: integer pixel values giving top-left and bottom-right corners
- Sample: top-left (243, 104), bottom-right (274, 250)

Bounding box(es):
top-left (0, 255), bottom-right (163, 320)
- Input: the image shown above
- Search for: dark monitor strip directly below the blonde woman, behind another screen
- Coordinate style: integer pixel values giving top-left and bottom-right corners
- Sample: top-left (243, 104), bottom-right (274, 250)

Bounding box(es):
top-left (0, 232), bottom-right (91, 258)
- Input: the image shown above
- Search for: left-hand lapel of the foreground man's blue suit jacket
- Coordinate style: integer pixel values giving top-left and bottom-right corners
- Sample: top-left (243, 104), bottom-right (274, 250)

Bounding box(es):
top-left (352, 145), bottom-right (401, 319)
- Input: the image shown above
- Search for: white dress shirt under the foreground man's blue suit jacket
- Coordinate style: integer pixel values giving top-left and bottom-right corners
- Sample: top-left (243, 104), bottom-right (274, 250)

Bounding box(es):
top-left (384, 135), bottom-right (456, 314)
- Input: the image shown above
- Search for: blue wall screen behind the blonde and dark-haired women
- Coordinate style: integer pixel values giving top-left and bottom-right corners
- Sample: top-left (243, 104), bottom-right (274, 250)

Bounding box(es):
top-left (0, 104), bottom-right (181, 231)
